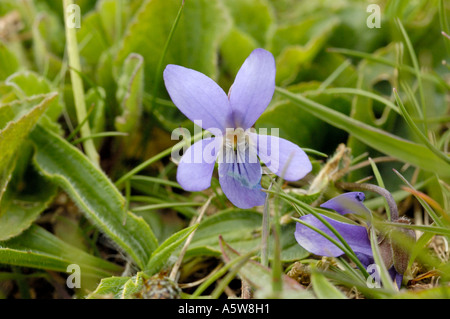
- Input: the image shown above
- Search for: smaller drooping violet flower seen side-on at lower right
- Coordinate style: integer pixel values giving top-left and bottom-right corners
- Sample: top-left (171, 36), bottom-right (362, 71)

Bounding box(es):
top-left (294, 192), bottom-right (403, 288)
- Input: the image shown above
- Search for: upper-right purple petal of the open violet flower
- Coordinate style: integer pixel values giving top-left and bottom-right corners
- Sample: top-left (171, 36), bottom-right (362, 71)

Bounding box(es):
top-left (229, 49), bottom-right (275, 129)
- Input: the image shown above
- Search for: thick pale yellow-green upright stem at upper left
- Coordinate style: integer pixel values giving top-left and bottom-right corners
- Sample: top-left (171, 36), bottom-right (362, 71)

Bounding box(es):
top-left (64, 0), bottom-right (99, 165)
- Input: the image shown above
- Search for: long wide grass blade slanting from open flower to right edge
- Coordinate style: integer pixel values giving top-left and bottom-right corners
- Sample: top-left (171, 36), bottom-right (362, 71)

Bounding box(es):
top-left (276, 88), bottom-right (450, 177)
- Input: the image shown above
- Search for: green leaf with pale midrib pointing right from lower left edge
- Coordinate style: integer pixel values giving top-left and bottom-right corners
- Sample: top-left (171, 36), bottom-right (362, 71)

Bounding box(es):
top-left (0, 225), bottom-right (121, 277)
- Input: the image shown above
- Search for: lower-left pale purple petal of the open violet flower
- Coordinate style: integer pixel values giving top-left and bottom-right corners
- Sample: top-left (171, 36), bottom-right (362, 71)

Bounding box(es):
top-left (177, 138), bottom-right (221, 192)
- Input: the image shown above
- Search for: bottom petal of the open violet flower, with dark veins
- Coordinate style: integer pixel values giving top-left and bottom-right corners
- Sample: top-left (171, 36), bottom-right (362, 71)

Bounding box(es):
top-left (219, 155), bottom-right (266, 209)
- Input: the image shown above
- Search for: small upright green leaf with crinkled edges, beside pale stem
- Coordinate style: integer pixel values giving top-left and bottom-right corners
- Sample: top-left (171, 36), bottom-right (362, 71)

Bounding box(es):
top-left (115, 53), bottom-right (144, 133)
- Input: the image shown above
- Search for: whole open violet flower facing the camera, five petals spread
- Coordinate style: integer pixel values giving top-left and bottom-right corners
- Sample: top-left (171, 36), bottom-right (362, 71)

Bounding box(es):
top-left (164, 49), bottom-right (312, 208)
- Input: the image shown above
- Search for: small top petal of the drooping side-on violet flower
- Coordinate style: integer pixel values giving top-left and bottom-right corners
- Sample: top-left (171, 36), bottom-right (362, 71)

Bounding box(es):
top-left (320, 192), bottom-right (370, 215)
